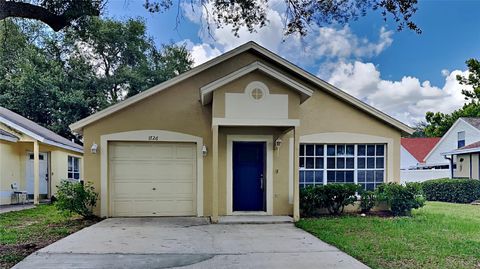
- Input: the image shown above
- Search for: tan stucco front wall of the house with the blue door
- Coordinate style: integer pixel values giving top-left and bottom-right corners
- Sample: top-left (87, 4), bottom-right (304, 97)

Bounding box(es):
top-left (83, 49), bottom-right (400, 216)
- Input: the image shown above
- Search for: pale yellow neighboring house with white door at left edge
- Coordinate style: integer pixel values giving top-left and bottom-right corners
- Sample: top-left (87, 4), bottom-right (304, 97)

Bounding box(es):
top-left (0, 107), bottom-right (83, 205)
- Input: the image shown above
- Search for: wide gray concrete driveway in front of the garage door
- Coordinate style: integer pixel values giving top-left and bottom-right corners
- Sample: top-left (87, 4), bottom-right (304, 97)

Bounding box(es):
top-left (14, 218), bottom-right (368, 269)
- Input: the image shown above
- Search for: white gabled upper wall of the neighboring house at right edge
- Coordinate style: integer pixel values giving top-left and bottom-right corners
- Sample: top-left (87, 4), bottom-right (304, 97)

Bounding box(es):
top-left (425, 118), bottom-right (480, 168)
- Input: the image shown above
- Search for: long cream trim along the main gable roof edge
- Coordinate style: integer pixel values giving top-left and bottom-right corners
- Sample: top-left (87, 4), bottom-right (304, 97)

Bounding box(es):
top-left (70, 41), bottom-right (414, 134)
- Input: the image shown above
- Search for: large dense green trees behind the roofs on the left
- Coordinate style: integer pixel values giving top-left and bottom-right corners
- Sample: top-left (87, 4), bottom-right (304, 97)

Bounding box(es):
top-left (0, 18), bottom-right (193, 138)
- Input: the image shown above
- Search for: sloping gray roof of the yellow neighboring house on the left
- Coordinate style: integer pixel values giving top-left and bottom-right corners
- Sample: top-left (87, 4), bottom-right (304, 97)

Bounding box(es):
top-left (0, 107), bottom-right (83, 152)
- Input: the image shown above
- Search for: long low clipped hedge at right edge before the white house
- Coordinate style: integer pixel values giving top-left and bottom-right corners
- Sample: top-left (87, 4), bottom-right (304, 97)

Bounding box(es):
top-left (422, 178), bottom-right (480, 203)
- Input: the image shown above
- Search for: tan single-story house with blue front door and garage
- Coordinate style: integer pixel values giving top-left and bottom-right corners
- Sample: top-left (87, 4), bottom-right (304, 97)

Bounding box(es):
top-left (70, 42), bottom-right (413, 222)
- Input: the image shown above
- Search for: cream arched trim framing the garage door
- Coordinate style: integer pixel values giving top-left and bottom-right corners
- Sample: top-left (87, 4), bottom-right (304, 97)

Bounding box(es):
top-left (100, 130), bottom-right (203, 217)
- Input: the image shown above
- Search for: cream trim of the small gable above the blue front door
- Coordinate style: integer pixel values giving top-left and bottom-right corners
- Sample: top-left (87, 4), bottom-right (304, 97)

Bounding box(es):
top-left (200, 62), bottom-right (313, 105)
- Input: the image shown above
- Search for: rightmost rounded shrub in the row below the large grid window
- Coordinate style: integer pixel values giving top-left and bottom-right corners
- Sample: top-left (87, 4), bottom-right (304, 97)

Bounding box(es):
top-left (375, 183), bottom-right (425, 216)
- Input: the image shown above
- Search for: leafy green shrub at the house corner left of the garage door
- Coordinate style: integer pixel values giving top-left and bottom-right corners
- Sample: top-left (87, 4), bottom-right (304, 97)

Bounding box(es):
top-left (55, 180), bottom-right (98, 218)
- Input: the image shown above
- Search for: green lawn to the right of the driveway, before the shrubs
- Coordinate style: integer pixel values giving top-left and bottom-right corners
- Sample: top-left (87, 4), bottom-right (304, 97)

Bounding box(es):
top-left (297, 202), bottom-right (480, 268)
